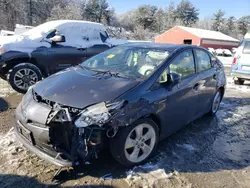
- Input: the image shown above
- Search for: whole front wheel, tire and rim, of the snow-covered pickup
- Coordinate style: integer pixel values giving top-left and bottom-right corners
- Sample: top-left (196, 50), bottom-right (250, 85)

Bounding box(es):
top-left (7, 63), bottom-right (42, 93)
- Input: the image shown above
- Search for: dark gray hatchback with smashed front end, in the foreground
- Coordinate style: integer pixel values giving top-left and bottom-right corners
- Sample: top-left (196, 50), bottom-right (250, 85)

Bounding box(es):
top-left (15, 43), bottom-right (226, 167)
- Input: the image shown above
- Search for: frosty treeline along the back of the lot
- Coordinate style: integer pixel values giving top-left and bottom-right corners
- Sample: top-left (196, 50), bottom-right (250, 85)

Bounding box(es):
top-left (0, 0), bottom-right (250, 40)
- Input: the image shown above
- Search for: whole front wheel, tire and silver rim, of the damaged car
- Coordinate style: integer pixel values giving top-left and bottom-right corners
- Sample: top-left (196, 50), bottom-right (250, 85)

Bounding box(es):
top-left (110, 118), bottom-right (159, 168)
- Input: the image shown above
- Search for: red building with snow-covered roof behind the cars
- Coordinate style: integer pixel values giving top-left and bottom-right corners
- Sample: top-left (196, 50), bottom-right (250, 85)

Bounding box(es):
top-left (155, 26), bottom-right (240, 50)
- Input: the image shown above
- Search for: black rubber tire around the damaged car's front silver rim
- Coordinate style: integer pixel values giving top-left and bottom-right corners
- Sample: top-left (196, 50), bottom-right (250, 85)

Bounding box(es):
top-left (109, 118), bottom-right (159, 168)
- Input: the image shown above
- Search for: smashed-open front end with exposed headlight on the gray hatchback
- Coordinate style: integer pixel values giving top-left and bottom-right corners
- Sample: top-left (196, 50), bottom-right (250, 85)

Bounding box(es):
top-left (18, 91), bottom-right (125, 166)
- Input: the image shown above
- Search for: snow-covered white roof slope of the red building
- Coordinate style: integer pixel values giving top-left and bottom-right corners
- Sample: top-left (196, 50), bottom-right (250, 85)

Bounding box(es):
top-left (177, 26), bottom-right (239, 42)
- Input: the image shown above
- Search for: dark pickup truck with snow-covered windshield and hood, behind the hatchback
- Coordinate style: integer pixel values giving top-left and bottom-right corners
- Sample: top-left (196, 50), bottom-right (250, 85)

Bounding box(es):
top-left (0, 20), bottom-right (126, 93)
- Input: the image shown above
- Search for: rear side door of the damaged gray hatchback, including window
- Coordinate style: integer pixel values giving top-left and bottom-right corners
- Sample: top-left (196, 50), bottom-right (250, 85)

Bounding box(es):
top-left (194, 49), bottom-right (218, 116)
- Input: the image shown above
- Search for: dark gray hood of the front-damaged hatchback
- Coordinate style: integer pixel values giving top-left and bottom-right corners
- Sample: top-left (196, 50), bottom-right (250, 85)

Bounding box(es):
top-left (33, 66), bottom-right (139, 109)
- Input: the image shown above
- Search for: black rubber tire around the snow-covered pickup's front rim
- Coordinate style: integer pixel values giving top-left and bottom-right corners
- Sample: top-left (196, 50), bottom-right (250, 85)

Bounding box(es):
top-left (8, 63), bottom-right (42, 93)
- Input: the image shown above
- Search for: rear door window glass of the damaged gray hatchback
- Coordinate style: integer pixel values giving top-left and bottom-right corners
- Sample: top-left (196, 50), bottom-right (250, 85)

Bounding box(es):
top-left (195, 49), bottom-right (212, 72)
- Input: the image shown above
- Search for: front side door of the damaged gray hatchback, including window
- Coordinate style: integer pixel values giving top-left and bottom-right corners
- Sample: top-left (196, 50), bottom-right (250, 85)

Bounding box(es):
top-left (154, 50), bottom-right (199, 136)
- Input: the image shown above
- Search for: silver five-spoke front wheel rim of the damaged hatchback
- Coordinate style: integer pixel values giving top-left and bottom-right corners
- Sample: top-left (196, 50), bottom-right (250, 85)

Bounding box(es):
top-left (124, 124), bottom-right (156, 163)
